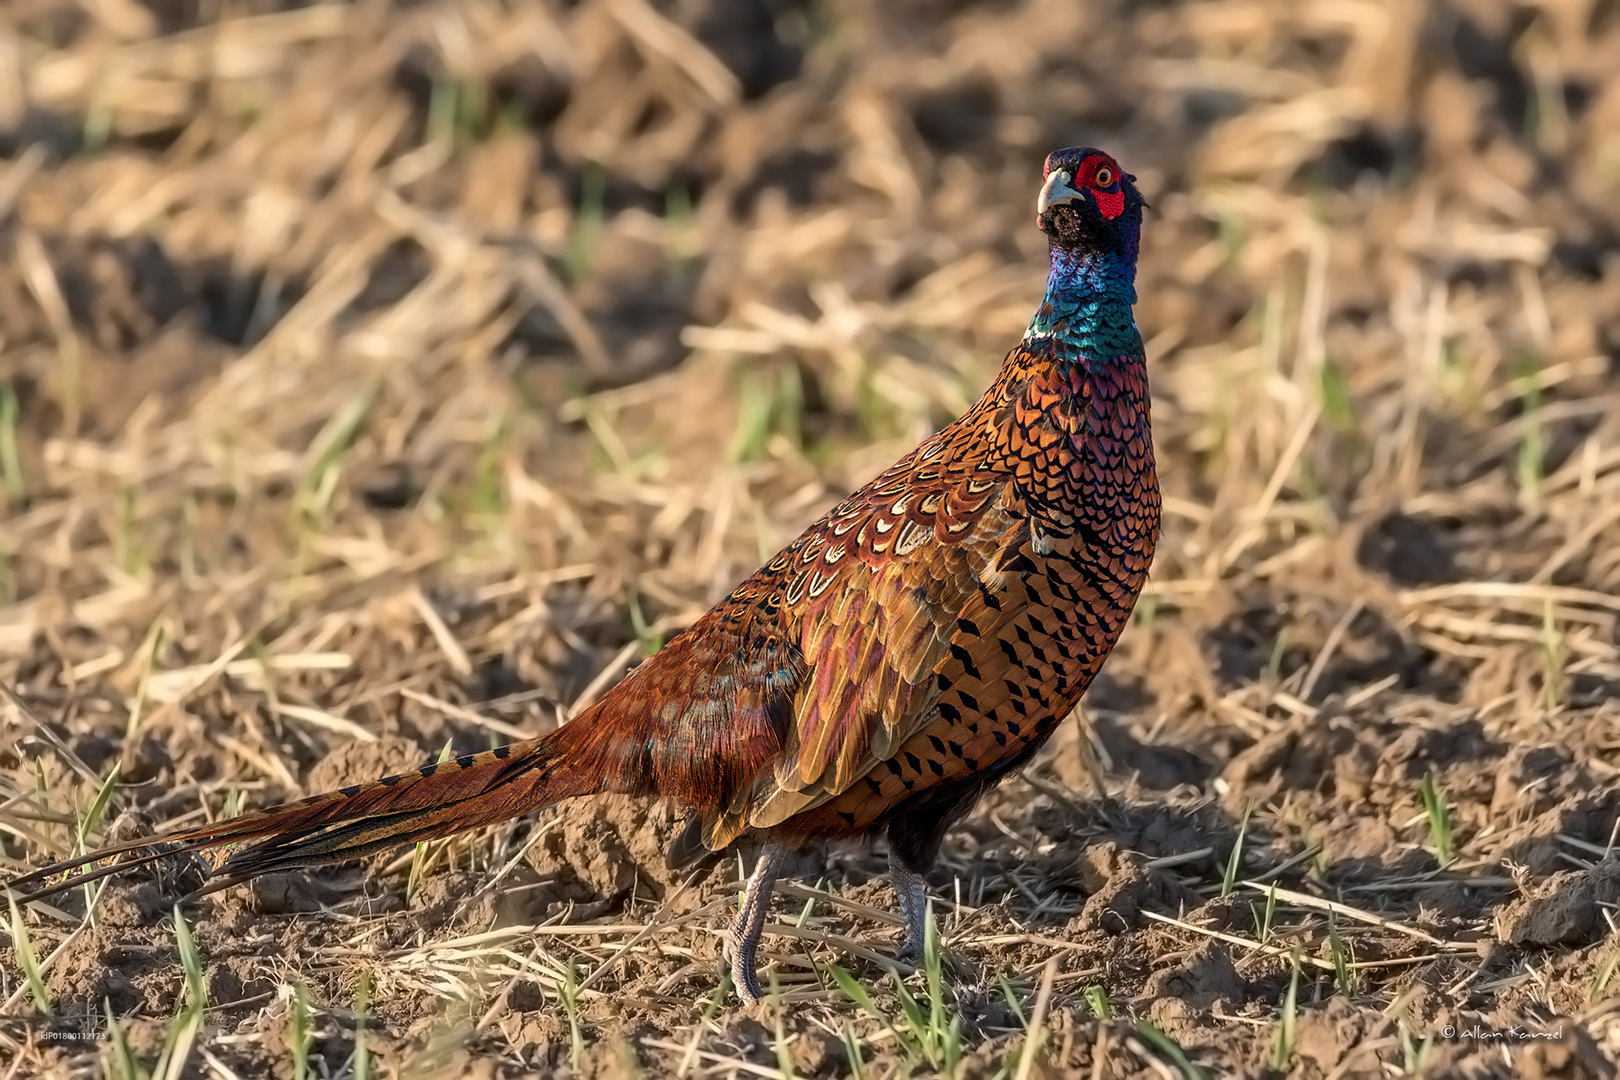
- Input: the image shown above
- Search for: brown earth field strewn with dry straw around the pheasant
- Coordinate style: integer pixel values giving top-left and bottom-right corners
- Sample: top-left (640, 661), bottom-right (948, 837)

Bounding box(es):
top-left (0, 0), bottom-right (1620, 1078)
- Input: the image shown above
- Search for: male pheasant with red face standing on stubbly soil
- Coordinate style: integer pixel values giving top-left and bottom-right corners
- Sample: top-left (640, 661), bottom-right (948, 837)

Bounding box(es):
top-left (8, 147), bottom-right (1160, 1004)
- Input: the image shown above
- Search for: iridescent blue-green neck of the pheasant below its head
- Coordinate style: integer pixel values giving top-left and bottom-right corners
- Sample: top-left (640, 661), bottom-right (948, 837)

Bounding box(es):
top-left (1024, 248), bottom-right (1142, 364)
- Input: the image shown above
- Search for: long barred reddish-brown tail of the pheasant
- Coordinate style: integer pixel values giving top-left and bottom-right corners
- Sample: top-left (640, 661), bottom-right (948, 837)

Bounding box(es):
top-left (3, 725), bottom-right (599, 900)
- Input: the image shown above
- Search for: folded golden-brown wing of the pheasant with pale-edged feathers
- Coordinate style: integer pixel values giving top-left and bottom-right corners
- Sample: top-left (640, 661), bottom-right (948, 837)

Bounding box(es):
top-left (735, 393), bottom-right (1027, 822)
